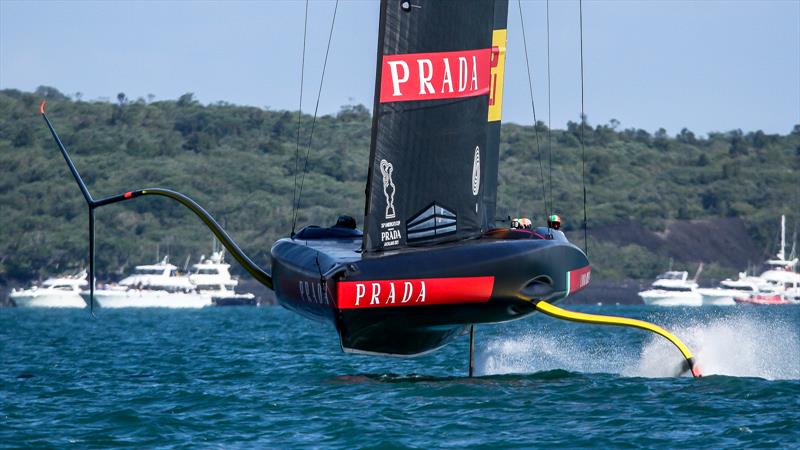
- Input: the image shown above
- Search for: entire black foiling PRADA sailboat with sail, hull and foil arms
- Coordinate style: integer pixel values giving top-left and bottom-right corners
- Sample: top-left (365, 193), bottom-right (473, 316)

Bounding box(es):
top-left (41, 0), bottom-right (699, 375)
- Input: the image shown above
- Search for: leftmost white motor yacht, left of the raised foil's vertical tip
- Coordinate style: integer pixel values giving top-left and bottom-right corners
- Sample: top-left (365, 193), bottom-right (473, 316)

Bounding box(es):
top-left (8, 270), bottom-right (89, 308)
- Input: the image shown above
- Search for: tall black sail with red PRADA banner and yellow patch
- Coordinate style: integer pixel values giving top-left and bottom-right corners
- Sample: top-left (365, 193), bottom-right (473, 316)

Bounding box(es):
top-left (364, 0), bottom-right (508, 251)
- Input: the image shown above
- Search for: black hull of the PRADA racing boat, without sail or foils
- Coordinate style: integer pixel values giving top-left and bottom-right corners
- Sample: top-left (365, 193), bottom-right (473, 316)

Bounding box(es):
top-left (272, 233), bottom-right (590, 356)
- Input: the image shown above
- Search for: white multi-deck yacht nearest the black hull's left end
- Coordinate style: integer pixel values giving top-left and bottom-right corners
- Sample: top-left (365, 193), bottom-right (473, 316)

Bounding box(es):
top-left (189, 250), bottom-right (256, 306)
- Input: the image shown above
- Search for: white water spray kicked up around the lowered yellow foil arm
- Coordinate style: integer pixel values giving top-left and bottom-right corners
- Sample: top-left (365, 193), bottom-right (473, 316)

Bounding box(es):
top-left (476, 316), bottom-right (800, 380)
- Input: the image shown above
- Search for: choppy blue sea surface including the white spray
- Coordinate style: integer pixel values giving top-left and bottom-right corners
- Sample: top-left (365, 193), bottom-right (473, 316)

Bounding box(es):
top-left (0, 306), bottom-right (800, 448)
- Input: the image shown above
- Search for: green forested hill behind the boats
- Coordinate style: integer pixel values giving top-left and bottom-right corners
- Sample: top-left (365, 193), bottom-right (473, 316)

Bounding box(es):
top-left (0, 88), bottom-right (800, 284)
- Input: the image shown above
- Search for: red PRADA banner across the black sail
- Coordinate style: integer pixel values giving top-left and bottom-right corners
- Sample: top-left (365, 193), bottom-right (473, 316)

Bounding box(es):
top-left (380, 48), bottom-right (492, 103)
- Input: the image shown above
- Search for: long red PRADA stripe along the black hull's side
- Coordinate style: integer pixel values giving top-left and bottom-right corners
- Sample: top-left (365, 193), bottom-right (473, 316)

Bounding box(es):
top-left (337, 277), bottom-right (494, 309)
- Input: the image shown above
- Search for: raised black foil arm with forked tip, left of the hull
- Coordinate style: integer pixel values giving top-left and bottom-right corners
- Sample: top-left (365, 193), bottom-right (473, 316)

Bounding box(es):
top-left (39, 101), bottom-right (272, 312)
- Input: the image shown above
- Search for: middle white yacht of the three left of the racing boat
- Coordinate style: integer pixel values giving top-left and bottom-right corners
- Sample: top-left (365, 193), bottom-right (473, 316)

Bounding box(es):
top-left (81, 257), bottom-right (212, 308)
